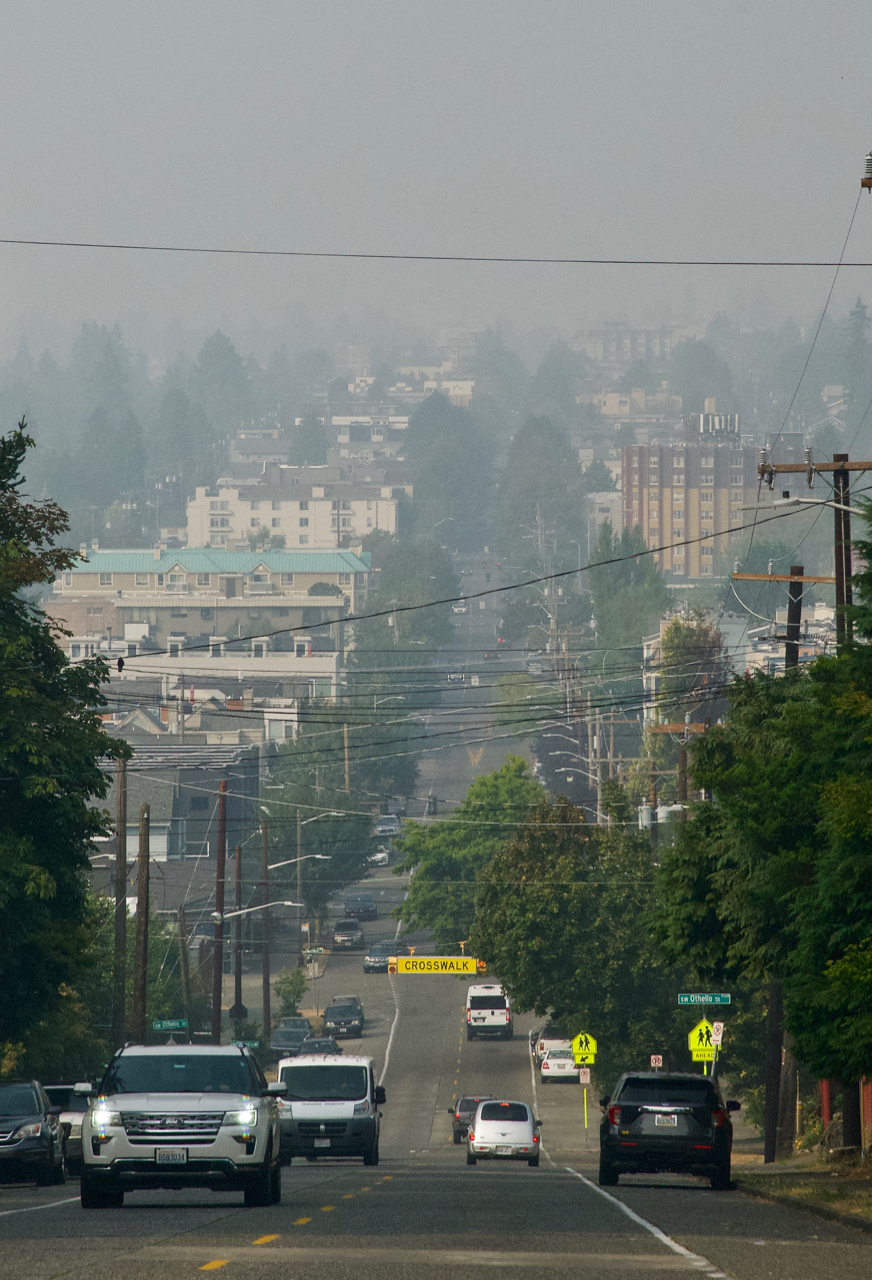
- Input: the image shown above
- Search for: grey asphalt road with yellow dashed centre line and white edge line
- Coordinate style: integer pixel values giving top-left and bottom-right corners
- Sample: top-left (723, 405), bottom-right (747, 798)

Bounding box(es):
top-left (0, 919), bottom-right (872, 1280)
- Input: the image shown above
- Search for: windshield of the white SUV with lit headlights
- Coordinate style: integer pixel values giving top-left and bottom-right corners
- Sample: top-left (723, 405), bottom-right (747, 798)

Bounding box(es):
top-left (100, 1050), bottom-right (260, 1097)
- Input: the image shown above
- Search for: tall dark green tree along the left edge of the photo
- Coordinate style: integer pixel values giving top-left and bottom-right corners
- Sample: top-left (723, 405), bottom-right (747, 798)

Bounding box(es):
top-left (0, 421), bottom-right (127, 1043)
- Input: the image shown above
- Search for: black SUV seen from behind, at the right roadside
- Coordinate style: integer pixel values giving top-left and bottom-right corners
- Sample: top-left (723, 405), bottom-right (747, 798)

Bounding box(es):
top-left (599, 1071), bottom-right (739, 1190)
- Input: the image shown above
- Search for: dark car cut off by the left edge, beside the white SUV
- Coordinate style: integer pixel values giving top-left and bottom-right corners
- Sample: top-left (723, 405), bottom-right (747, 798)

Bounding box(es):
top-left (0, 1080), bottom-right (67, 1187)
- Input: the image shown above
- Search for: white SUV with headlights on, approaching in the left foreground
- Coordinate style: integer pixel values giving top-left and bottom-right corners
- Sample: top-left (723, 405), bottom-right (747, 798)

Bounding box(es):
top-left (76, 1044), bottom-right (281, 1208)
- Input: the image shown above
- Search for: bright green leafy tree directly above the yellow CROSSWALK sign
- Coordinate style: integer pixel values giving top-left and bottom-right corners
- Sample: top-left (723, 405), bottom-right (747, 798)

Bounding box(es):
top-left (394, 755), bottom-right (544, 951)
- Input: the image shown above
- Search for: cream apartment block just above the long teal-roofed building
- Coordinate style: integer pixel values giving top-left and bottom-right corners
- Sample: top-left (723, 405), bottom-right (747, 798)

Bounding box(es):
top-left (187, 466), bottom-right (411, 550)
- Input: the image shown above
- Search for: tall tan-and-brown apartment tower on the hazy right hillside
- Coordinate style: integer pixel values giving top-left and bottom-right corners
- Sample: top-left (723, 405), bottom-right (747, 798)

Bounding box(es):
top-left (621, 439), bottom-right (758, 580)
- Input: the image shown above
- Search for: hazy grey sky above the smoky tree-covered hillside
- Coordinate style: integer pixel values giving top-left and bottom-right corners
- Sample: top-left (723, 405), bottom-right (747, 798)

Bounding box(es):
top-left (0, 0), bottom-right (872, 355)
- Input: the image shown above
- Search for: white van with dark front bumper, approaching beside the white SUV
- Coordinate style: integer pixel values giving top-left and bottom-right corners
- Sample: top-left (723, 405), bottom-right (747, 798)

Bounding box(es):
top-left (278, 1053), bottom-right (385, 1165)
